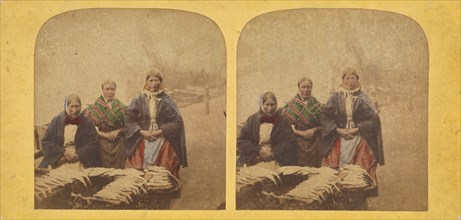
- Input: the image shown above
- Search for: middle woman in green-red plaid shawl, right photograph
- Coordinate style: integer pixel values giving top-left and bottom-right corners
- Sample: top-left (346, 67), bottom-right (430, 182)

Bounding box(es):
top-left (282, 77), bottom-right (323, 167)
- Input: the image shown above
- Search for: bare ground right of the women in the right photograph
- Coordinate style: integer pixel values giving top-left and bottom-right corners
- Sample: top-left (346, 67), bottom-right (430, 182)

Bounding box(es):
top-left (368, 99), bottom-right (428, 211)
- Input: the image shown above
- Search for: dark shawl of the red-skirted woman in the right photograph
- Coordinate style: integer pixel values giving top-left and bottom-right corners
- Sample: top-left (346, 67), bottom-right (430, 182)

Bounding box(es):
top-left (320, 91), bottom-right (384, 165)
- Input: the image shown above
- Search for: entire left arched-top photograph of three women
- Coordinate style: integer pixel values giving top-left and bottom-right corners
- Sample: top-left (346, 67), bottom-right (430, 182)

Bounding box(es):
top-left (33, 8), bottom-right (227, 210)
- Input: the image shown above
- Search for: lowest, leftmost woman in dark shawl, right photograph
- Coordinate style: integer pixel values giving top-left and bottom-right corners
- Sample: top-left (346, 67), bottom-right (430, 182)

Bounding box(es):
top-left (237, 92), bottom-right (298, 169)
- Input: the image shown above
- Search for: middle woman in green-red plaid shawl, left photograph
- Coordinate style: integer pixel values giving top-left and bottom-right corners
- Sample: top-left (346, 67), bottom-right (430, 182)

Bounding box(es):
top-left (86, 80), bottom-right (127, 169)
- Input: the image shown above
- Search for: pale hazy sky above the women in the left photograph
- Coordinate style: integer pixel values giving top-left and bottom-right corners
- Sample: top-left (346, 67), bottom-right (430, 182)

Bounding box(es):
top-left (35, 9), bottom-right (226, 124)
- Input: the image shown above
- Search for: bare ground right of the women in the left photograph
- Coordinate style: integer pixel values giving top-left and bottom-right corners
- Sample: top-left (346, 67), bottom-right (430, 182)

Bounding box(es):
top-left (171, 95), bottom-right (226, 210)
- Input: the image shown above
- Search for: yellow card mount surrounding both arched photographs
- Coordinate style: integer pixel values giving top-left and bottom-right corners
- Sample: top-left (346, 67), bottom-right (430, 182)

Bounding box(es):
top-left (0, 0), bottom-right (461, 219)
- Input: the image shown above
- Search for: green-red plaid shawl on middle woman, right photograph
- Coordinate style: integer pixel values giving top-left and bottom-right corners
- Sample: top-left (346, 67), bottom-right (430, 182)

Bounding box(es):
top-left (284, 94), bottom-right (323, 127)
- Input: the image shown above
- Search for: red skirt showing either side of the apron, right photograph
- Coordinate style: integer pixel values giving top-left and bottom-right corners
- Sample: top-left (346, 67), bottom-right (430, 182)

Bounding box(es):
top-left (322, 138), bottom-right (378, 186)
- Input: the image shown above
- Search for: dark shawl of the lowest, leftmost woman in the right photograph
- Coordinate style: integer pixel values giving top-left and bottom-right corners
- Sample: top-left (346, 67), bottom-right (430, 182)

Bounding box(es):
top-left (237, 111), bottom-right (298, 167)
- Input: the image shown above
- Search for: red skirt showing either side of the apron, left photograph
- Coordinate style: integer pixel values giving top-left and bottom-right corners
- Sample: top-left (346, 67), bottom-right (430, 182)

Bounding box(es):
top-left (125, 140), bottom-right (181, 179)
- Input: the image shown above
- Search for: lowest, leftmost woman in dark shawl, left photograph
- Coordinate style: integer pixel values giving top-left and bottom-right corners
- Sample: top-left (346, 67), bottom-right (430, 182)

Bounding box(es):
top-left (39, 94), bottom-right (99, 169)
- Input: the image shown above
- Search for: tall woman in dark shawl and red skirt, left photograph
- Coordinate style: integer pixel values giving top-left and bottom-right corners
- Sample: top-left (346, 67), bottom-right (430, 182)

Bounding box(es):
top-left (125, 69), bottom-right (187, 177)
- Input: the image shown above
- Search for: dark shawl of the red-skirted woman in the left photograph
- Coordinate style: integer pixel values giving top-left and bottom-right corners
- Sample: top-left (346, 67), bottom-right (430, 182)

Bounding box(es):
top-left (124, 92), bottom-right (188, 167)
